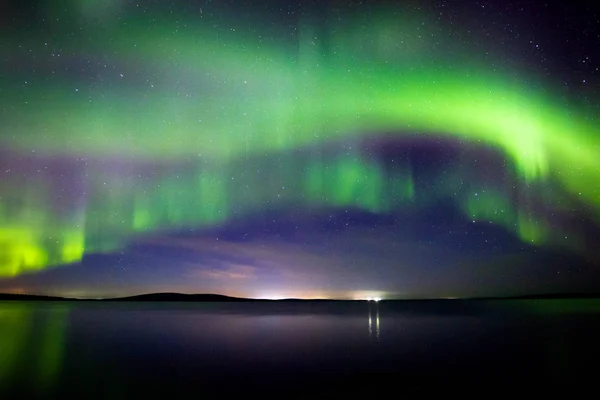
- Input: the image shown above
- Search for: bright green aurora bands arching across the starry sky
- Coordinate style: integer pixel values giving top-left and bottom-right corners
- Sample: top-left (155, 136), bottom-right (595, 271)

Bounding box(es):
top-left (0, 8), bottom-right (600, 277)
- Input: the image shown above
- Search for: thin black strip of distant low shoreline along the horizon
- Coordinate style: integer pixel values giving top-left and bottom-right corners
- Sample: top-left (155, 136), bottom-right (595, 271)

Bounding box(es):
top-left (0, 293), bottom-right (600, 303)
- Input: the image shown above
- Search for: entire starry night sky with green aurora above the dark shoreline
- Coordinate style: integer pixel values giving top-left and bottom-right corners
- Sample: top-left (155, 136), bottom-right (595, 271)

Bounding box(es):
top-left (0, 0), bottom-right (600, 298)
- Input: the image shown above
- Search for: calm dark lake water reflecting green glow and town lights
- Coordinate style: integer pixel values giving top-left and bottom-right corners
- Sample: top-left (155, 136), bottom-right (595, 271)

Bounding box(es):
top-left (0, 300), bottom-right (600, 399)
